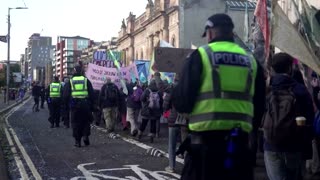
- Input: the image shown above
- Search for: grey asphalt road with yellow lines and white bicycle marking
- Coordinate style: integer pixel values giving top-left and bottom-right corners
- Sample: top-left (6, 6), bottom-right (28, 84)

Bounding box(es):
top-left (5, 100), bottom-right (266, 180)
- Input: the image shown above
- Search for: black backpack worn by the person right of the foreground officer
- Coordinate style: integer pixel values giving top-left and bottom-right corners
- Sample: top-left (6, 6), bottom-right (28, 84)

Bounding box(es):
top-left (262, 88), bottom-right (298, 145)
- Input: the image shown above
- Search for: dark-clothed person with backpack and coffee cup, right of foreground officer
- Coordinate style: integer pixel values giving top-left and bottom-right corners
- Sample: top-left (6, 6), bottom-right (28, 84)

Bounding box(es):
top-left (262, 53), bottom-right (314, 180)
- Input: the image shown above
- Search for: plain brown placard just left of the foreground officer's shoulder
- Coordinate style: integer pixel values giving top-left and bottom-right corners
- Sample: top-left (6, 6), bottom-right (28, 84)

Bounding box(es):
top-left (154, 47), bottom-right (194, 73)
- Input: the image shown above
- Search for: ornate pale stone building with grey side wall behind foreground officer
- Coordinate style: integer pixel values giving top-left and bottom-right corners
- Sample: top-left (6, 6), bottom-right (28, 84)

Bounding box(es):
top-left (118, 0), bottom-right (255, 64)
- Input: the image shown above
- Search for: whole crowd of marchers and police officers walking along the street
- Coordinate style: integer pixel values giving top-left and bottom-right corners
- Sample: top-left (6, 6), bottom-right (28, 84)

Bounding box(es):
top-left (29, 14), bottom-right (320, 180)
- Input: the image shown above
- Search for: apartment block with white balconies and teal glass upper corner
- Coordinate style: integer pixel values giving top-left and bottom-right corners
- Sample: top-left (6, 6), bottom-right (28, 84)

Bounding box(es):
top-left (52, 36), bottom-right (93, 80)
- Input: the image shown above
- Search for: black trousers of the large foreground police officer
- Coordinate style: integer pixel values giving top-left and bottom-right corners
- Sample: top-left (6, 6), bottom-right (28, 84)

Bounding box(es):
top-left (181, 132), bottom-right (253, 180)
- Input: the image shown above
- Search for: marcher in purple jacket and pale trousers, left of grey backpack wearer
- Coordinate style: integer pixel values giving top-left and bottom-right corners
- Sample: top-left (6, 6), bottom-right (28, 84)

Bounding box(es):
top-left (127, 82), bottom-right (143, 136)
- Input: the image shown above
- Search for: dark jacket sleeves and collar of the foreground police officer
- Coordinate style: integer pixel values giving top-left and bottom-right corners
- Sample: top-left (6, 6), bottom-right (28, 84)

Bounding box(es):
top-left (172, 39), bottom-right (266, 135)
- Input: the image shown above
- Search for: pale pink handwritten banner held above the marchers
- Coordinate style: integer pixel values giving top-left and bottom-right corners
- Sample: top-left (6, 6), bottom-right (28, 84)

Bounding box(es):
top-left (86, 63), bottom-right (139, 90)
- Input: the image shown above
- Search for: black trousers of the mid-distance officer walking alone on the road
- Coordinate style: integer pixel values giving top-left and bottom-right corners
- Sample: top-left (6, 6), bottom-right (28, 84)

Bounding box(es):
top-left (70, 108), bottom-right (91, 141)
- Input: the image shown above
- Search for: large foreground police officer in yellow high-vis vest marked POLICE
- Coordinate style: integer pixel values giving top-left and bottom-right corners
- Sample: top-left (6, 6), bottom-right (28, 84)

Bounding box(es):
top-left (172, 14), bottom-right (265, 180)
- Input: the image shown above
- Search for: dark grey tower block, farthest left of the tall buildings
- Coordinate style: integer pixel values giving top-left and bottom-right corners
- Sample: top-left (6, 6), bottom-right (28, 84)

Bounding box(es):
top-left (25, 33), bottom-right (52, 82)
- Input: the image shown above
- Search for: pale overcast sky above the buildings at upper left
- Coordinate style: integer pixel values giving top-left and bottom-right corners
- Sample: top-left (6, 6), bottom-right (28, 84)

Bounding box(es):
top-left (0, 0), bottom-right (147, 60)
